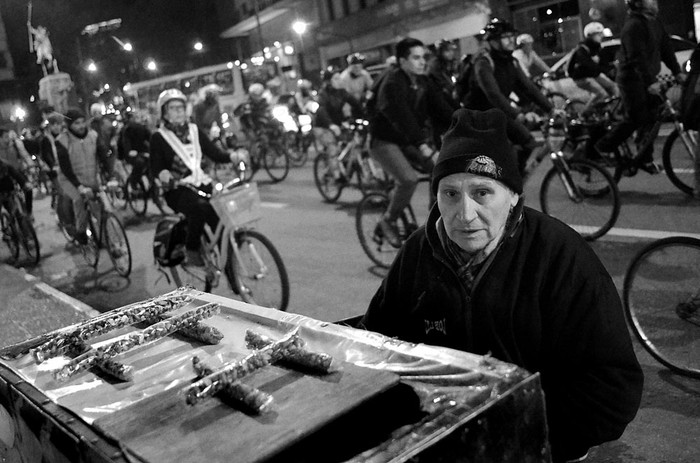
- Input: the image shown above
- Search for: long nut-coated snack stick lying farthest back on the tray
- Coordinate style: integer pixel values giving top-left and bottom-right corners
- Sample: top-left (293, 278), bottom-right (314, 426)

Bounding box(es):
top-left (31, 288), bottom-right (193, 363)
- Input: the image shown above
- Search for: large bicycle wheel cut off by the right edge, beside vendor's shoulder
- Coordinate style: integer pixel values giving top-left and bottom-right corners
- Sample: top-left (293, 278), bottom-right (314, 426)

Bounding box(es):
top-left (622, 237), bottom-right (700, 378)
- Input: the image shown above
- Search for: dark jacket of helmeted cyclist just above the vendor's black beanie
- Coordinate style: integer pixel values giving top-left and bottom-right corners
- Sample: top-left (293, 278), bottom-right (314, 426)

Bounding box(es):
top-left (463, 51), bottom-right (552, 118)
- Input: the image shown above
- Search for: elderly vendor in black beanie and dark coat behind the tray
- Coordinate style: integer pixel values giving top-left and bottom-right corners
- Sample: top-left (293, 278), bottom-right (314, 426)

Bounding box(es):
top-left (360, 109), bottom-right (643, 462)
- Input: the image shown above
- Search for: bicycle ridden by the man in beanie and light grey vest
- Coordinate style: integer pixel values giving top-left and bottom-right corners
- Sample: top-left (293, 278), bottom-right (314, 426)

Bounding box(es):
top-left (65, 186), bottom-right (132, 277)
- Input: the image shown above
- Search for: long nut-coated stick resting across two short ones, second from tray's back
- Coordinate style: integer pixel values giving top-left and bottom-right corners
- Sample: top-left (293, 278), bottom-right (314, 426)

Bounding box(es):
top-left (54, 303), bottom-right (219, 380)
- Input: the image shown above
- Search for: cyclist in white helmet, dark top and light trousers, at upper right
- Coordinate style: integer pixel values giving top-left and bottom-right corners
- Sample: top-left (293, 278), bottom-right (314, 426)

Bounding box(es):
top-left (567, 21), bottom-right (620, 114)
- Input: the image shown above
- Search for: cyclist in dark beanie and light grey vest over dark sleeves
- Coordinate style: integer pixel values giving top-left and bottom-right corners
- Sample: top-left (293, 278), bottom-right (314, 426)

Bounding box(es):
top-left (56, 108), bottom-right (109, 244)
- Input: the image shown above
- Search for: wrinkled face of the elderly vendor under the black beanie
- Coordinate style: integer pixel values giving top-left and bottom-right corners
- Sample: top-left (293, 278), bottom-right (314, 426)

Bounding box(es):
top-left (437, 173), bottom-right (518, 254)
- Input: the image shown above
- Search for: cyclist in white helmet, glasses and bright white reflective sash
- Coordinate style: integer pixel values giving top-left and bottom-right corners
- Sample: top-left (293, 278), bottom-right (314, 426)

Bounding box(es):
top-left (150, 89), bottom-right (239, 267)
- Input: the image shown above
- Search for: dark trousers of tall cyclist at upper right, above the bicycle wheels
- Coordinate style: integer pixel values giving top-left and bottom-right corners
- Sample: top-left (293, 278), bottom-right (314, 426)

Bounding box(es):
top-left (596, 80), bottom-right (661, 164)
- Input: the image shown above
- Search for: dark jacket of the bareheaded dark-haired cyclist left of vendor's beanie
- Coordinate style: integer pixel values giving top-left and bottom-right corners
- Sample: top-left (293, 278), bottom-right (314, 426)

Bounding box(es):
top-left (370, 68), bottom-right (453, 147)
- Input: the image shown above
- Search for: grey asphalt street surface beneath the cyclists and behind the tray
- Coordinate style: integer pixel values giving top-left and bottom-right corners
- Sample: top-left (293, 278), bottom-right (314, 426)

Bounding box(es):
top-left (0, 139), bottom-right (700, 462)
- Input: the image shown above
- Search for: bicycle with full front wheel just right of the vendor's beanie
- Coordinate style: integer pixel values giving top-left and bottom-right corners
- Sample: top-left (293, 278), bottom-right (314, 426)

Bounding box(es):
top-left (523, 110), bottom-right (620, 241)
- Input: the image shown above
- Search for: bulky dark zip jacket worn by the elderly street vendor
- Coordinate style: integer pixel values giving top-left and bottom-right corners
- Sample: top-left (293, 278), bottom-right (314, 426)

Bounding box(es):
top-left (362, 206), bottom-right (643, 461)
